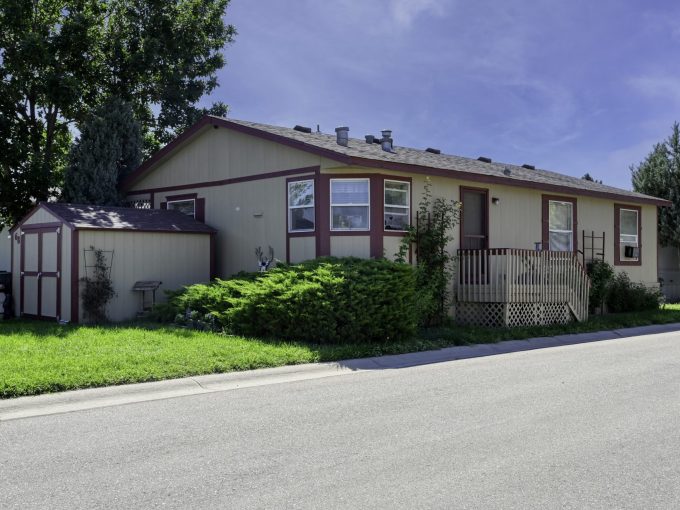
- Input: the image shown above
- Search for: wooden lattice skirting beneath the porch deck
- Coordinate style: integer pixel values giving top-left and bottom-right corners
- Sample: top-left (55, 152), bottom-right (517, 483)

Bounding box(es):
top-left (456, 303), bottom-right (572, 327)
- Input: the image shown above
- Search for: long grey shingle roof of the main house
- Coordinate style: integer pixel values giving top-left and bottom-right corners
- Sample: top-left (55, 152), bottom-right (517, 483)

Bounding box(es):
top-left (219, 118), bottom-right (663, 203)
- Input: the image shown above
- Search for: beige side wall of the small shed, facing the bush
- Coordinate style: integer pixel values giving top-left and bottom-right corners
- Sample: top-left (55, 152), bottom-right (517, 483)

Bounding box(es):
top-left (78, 230), bottom-right (210, 321)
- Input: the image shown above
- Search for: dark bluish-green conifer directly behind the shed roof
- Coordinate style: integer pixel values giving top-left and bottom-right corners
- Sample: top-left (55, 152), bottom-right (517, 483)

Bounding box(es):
top-left (62, 98), bottom-right (143, 205)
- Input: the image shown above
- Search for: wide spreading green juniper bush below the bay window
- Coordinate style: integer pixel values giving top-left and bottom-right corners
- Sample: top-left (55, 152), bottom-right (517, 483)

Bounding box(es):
top-left (170, 258), bottom-right (418, 343)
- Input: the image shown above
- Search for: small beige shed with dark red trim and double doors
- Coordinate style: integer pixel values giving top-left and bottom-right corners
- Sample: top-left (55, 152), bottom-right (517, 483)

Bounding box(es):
top-left (11, 203), bottom-right (216, 322)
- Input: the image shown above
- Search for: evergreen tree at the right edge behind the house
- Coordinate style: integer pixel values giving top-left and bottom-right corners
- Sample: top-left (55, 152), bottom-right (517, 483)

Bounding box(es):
top-left (630, 122), bottom-right (680, 248)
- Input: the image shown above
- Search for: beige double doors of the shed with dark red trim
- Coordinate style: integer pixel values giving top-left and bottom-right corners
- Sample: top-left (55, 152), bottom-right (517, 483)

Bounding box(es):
top-left (20, 225), bottom-right (61, 320)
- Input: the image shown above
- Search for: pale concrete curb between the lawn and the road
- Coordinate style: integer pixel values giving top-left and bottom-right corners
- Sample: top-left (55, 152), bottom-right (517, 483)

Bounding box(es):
top-left (0, 323), bottom-right (680, 422)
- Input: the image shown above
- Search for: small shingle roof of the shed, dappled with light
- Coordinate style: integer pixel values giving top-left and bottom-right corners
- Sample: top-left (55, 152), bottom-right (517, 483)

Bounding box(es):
top-left (41, 203), bottom-right (215, 234)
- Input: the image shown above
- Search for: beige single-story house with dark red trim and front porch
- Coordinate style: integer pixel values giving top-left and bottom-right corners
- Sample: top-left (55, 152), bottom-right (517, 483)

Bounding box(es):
top-left (118, 116), bottom-right (667, 325)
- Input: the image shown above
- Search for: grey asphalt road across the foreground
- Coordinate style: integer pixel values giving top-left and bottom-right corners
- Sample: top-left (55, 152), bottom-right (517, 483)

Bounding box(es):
top-left (0, 333), bottom-right (680, 509)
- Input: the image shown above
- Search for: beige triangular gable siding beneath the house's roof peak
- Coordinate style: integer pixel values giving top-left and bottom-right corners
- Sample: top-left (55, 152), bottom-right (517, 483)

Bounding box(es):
top-left (133, 128), bottom-right (321, 190)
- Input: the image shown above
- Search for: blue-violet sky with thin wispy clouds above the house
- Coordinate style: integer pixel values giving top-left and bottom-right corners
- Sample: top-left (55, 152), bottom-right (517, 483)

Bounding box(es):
top-left (206, 0), bottom-right (680, 189)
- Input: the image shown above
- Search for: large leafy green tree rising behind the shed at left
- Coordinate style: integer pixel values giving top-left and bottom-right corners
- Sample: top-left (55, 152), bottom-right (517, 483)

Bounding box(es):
top-left (0, 0), bottom-right (235, 227)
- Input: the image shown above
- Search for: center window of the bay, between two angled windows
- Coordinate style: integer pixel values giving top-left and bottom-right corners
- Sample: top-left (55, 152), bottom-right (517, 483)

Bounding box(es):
top-left (331, 179), bottom-right (370, 230)
